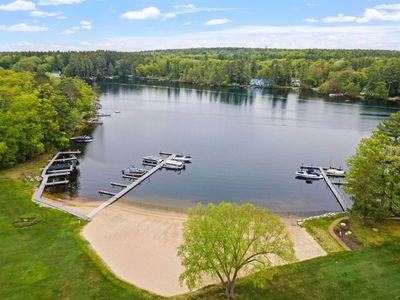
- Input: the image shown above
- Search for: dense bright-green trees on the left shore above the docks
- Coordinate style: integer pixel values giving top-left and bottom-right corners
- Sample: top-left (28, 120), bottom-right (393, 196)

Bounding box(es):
top-left (0, 67), bottom-right (97, 169)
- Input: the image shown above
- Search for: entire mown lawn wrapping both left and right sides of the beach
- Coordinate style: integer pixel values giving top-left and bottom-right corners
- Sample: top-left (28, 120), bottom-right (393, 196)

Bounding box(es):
top-left (0, 170), bottom-right (400, 300)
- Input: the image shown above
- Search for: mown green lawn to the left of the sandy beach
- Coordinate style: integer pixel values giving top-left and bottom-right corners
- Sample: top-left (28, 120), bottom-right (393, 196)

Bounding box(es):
top-left (0, 177), bottom-right (156, 299)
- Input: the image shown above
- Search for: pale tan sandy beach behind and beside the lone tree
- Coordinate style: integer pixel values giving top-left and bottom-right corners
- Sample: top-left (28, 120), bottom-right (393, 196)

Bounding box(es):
top-left (59, 201), bottom-right (326, 296)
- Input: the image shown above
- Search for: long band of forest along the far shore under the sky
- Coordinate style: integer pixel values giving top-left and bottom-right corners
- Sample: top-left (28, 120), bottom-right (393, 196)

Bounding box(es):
top-left (0, 48), bottom-right (400, 100)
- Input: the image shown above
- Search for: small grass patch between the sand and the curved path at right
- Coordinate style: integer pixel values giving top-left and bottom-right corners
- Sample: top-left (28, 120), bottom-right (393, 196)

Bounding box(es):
top-left (302, 216), bottom-right (344, 253)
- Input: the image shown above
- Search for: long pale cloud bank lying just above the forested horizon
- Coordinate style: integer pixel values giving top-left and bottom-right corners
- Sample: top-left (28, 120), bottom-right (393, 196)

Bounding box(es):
top-left (0, 25), bottom-right (400, 51)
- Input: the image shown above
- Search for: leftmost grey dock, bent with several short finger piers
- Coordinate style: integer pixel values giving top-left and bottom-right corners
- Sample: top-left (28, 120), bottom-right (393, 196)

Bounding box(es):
top-left (32, 151), bottom-right (89, 221)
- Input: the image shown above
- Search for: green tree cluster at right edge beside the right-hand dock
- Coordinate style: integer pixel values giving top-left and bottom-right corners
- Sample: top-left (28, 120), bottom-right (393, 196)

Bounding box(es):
top-left (345, 112), bottom-right (400, 224)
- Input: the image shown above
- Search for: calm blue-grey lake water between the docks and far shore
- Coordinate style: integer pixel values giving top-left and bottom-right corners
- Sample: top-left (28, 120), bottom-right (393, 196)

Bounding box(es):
top-left (53, 83), bottom-right (398, 215)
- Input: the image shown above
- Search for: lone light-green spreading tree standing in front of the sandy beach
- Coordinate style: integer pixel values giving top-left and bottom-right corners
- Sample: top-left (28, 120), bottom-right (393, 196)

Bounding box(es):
top-left (178, 203), bottom-right (294, 299)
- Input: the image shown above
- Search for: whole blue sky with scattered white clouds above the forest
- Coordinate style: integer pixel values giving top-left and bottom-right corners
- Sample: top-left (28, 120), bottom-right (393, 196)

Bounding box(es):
top-left (0, 0), bottom-right (400, 51)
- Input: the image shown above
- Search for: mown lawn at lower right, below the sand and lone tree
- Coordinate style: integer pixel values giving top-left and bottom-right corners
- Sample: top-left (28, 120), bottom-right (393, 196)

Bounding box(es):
top-left (187, 240), bottom-right (400, 300)
